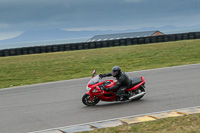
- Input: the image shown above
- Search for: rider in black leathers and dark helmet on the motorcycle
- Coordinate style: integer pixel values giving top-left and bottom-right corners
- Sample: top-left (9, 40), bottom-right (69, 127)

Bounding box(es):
top-left (99, 66), bottom-right (131, 100)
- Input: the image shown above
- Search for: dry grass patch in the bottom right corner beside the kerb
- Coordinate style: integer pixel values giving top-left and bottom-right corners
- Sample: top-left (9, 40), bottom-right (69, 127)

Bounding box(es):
top-left (81, 114), bottom-right (200, 133)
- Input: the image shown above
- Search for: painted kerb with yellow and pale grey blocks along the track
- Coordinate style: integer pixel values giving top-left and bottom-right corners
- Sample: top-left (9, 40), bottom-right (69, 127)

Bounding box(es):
top-left (30, 106), bottom-right (200, 133)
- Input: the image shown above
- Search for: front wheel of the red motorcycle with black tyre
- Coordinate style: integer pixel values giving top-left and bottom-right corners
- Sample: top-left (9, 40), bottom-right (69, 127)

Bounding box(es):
top-left (82, 94), bottom-right (100, 106)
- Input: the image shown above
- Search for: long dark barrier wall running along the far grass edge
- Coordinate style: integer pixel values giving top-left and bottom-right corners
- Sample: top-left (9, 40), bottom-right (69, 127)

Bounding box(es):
top-left (0, 32), bottom-right (200, 57)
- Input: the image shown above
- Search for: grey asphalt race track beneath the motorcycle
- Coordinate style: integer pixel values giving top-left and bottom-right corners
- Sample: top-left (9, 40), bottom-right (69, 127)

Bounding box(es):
top-left (0, 64), bottom-right (200, 133)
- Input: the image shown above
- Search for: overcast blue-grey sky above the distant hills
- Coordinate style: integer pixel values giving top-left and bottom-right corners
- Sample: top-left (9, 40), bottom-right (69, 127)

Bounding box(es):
top-left (0, 0), bottom-right (200, 39)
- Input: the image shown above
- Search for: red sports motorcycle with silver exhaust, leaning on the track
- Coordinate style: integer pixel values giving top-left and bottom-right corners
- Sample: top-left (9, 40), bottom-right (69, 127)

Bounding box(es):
top-left (82, 70), bottom-right (146, 106)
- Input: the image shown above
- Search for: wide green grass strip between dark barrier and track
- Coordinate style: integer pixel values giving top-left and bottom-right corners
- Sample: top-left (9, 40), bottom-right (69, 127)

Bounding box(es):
top-left (0, 39), bottom-right (200, 88)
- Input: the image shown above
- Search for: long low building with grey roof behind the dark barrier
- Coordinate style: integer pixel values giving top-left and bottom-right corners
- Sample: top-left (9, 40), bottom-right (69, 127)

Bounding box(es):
top-left (88, 30), bottom-right (164, 42)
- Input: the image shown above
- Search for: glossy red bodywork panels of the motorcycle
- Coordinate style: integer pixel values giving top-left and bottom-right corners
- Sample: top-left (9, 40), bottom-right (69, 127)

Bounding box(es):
top-left (86, 77), bottom-right (145, 101)
